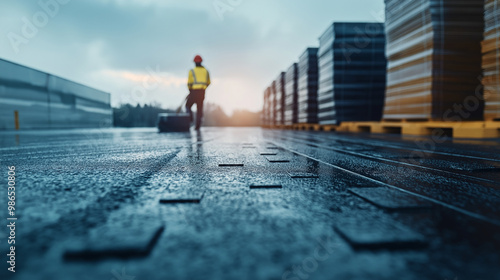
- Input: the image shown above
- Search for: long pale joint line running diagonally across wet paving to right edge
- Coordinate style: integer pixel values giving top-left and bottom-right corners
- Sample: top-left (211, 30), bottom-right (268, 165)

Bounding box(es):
top-left (270, 140), bottom-right (500, 226)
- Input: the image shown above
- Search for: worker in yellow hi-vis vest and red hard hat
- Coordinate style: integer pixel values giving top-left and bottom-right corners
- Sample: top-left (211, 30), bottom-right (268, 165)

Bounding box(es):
top-left (186, 55), bottom-right (210, 130)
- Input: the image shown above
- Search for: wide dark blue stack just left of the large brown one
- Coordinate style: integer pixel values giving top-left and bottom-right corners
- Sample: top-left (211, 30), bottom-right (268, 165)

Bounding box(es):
top-left (318, 23), bottom-right (387, 124)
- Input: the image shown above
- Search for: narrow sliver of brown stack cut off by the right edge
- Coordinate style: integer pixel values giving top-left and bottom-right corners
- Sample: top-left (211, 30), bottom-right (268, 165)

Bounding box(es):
top-left (483, 0), bottom-right (500, 120)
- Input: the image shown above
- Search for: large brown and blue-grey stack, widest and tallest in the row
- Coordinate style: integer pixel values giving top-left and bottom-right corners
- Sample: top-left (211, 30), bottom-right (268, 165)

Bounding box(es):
top-left (384, 0), bottom-right (484, 120)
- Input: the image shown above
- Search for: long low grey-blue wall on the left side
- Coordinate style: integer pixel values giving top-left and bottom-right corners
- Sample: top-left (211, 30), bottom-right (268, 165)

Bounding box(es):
top-left (0, 59), bottom-right (112, 130)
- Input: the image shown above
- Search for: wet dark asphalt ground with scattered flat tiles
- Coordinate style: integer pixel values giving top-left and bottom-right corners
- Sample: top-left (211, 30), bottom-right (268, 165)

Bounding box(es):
top-left (0, 128), bottom-right (500, 280)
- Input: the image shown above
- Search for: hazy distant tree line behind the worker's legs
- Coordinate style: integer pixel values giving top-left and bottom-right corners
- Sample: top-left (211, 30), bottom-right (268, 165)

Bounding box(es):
top-left (113, 103), bottom-right (261, 127)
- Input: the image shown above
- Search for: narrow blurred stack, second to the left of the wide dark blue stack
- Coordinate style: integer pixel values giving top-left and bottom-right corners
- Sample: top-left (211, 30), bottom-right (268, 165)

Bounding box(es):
top-left (285, 63), bottom-right (298, 125)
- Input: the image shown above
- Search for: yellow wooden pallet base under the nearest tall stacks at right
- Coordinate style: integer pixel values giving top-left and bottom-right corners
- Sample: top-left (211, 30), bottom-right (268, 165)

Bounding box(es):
top-left (339, 121), bottom-right (500, 139)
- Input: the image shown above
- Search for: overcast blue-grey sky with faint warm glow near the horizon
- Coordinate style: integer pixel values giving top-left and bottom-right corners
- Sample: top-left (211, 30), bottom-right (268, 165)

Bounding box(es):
top-left (0, 0), bottom-right (384, 113)
